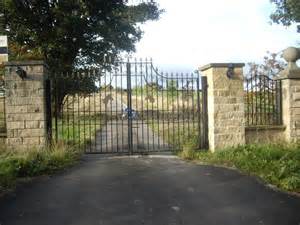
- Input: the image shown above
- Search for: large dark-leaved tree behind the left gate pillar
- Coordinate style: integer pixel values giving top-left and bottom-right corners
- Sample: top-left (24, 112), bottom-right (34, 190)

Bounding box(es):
top-left (0, 0), bottom-right (162, 114)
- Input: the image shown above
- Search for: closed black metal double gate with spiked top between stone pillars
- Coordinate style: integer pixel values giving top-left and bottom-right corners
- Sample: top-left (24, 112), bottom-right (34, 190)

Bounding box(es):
top-left (52, 60), bottom-right (208, 154)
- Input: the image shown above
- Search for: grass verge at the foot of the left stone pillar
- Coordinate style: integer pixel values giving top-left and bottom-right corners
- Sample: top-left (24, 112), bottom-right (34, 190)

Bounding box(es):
top-left (0, 144), bottom-right (82, 192)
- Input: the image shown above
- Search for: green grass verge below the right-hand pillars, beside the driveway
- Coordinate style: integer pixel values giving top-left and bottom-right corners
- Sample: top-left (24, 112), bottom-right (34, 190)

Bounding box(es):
top-left (179, 144), bottom-right (300, 193)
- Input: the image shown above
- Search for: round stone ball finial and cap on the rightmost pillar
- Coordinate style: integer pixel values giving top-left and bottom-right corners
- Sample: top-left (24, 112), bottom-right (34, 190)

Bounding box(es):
top-left (275, 47), bottom-right (300, 80)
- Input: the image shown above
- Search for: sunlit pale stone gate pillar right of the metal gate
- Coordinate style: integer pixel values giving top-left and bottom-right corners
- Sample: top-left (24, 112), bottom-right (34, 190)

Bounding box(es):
top-left (200, 63), bottom-right (245, 152)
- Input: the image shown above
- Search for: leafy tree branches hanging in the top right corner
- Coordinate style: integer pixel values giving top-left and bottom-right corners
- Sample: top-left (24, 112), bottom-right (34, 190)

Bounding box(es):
top-left (271, 0), bottom-right (300, 32)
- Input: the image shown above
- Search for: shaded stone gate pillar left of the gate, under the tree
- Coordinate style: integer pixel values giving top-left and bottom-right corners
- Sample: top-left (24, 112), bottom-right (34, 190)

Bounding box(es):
top-left (5, 61), bottom-right (47, 149)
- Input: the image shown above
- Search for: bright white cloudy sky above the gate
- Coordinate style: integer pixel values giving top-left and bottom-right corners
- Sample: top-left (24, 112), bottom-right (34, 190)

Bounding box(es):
top-left (133, 0), bottom-right (300, 72)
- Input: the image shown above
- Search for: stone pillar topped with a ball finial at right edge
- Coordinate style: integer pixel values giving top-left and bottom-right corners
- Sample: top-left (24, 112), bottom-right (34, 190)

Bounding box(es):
top-left (276, 47), bottom-right (300, 142)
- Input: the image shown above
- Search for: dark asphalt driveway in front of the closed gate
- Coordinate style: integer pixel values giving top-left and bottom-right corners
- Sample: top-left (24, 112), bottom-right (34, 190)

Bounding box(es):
top-left (0, 156), bottom-right (300, 225)
